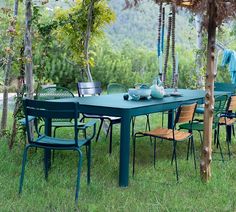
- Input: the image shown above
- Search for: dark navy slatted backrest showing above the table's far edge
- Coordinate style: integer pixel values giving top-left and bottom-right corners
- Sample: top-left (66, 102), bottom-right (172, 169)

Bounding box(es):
top-left (77, 82), bottom-right (102, 97)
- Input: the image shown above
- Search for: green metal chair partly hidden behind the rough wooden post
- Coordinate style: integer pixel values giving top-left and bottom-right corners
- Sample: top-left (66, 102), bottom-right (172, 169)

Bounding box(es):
top-left (179, 95), bottom-right (228, 161)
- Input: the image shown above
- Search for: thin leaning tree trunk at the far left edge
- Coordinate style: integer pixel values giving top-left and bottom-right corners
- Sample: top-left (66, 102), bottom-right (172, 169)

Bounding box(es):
top-left (1, 0), bottom-right (19, 134)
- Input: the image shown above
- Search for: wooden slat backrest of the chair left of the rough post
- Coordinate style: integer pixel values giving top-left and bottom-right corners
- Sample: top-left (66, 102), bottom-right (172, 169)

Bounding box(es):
top-left (175, 103), bottom-right (197, 124)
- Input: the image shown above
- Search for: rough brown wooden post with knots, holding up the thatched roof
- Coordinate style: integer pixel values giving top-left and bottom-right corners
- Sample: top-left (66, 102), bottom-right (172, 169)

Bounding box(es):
top-left (200, 0), bottom-right (217, 181)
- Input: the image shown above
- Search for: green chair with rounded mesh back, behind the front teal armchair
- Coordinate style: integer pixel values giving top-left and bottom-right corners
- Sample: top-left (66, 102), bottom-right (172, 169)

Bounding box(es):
top-left (36, 86), bottom-right (84, 137)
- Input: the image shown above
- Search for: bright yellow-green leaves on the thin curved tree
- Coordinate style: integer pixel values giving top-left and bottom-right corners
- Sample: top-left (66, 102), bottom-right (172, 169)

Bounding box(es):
top-left (54, 0), bottom-right (114, 67)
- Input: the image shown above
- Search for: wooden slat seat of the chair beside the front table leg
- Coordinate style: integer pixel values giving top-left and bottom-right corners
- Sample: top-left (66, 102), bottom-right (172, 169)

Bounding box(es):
top-left (143, 128), bottom-right (191, 141)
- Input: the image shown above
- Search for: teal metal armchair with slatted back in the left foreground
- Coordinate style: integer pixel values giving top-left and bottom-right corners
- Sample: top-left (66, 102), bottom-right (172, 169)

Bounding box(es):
top-left (19, 99), bottom-right (96, 203)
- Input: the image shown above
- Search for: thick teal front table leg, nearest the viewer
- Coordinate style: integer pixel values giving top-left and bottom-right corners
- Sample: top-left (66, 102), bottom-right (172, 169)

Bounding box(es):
top-left (119, 116), bottom-right (131, 187)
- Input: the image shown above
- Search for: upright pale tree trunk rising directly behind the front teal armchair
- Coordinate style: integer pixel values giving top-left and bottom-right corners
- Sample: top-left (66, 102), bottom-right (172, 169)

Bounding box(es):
top-left (25, 0), bottom-right (34, 99)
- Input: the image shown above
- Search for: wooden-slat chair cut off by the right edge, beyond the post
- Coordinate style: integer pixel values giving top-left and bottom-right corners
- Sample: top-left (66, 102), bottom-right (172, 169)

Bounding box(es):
top-left (219, 95), bottom-right (236, 158)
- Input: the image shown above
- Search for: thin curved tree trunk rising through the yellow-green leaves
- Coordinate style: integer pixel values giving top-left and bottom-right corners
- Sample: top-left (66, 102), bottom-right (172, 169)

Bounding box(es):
top-left (84, 0), bottom-right (96, 82)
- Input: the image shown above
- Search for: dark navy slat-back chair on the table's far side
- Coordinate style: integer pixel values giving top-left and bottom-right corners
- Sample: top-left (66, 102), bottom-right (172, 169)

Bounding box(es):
top-left (77, 82), bottom-right (121, 154)
